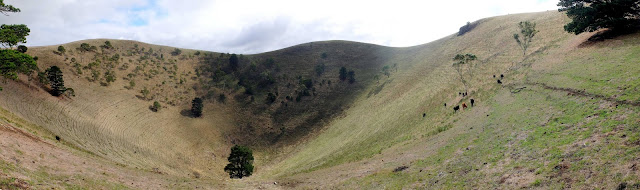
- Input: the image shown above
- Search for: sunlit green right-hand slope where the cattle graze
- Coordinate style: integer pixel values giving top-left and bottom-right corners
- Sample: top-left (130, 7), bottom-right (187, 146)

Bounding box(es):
top-left (271, 12), bottom-right (640, 189)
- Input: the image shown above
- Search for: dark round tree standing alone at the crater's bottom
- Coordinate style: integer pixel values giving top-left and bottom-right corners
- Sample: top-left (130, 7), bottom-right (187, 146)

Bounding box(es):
top-left (224, 145), bottom-right (253, 178)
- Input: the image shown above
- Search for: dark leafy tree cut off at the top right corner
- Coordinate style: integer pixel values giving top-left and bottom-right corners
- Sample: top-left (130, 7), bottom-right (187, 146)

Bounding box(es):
top-left (558, 0), bottom-right (640, 35)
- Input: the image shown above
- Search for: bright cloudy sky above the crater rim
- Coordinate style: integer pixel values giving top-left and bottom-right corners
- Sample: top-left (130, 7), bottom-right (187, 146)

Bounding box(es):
top-left (0, 0), bottom-right (558, 54)
